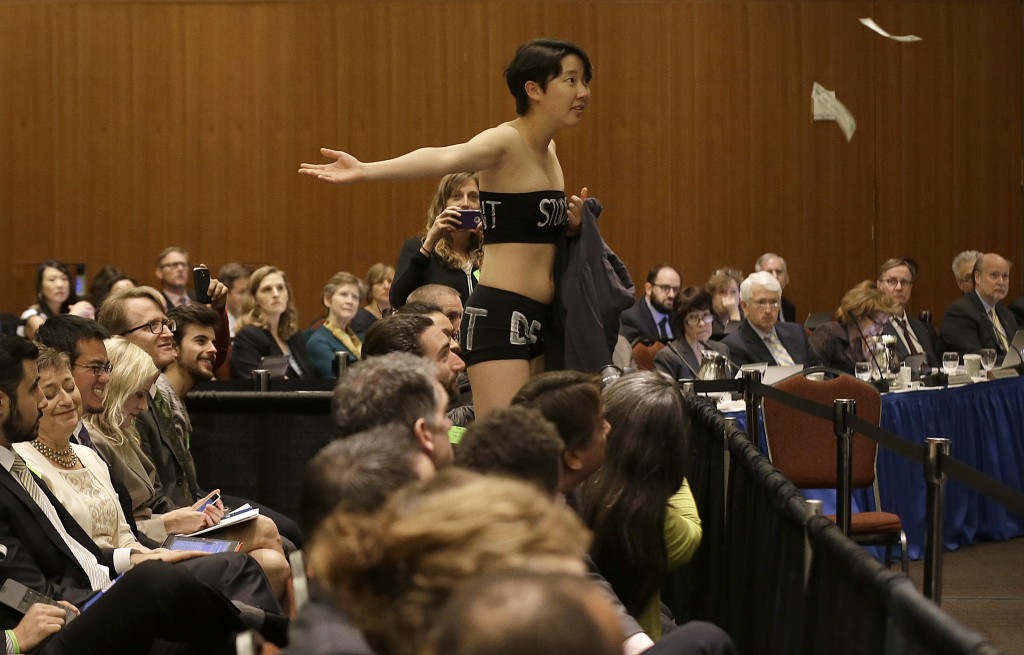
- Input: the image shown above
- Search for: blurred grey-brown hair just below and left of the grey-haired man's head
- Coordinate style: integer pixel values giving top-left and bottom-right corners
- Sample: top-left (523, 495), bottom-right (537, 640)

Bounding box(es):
top-left (299, 423), bottom-right (419, 535)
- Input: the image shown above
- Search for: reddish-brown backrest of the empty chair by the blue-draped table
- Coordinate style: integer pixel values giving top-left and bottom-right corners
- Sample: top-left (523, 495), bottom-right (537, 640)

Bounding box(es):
top-left (764, 375), bottom-right (882, 489)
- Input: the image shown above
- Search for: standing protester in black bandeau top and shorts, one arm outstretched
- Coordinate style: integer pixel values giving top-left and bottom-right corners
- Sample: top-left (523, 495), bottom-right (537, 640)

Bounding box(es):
top-left (299, 39), bottom-right (592, 417)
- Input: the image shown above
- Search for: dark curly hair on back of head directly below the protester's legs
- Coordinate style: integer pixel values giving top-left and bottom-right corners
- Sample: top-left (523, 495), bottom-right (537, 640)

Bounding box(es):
top-left (455, 406), bottom-right (565, 495)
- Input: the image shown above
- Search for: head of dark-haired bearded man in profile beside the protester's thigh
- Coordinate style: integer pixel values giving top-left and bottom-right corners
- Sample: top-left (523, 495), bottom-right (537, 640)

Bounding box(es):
top-left (362, 307), bottom-right (466, 409)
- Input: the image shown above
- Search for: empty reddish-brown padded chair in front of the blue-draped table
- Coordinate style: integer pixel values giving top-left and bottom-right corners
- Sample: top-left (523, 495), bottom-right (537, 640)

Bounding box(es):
top-left (764, 375), bottom-right (909, 573)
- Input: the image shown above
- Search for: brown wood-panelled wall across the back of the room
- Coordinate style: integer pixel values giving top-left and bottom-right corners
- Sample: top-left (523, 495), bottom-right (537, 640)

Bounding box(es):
top-left (0, 0), bottom-right (1024, 331)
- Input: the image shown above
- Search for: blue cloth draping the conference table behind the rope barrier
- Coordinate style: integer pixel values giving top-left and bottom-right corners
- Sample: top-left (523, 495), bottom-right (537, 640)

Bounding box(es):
top-left (726, 378), bottom-right (1024, 559)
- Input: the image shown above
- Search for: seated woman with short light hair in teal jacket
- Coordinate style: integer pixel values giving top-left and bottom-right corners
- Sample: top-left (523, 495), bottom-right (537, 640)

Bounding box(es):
top-left (306, 272), bottom-right (366, 380)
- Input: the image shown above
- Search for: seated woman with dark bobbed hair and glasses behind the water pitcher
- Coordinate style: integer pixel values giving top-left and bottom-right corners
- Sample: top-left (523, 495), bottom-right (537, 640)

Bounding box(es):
top-left (654, 287), bottom-right (729, 380)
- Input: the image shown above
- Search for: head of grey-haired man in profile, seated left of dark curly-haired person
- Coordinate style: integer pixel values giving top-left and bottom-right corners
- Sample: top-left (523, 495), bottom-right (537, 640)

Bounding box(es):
top-left (332, 352), bottom-right (452, 470)
